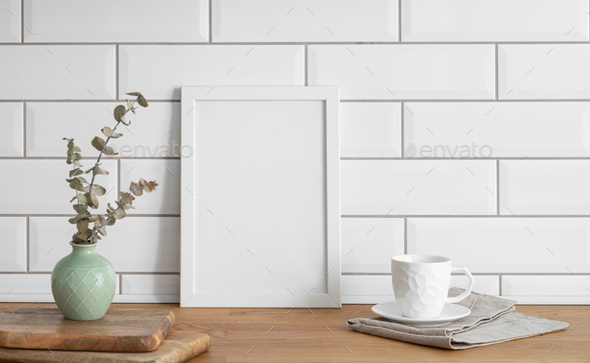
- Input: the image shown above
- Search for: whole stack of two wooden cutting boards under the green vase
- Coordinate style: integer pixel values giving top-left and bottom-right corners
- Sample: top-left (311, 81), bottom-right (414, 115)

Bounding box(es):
top-left (0, 307), bottom-right (211, 363)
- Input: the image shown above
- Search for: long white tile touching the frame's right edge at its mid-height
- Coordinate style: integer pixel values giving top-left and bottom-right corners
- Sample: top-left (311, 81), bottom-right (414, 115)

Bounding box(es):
top-left (340, 160), bottom-right (496, 215)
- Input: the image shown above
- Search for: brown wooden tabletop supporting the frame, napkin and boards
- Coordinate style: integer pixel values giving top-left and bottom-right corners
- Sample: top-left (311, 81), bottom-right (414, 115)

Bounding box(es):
top-left (4, 303), bottom-right (590, 363)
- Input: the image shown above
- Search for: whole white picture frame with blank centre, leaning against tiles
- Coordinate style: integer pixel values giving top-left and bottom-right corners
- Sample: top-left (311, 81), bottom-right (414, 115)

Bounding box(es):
top-left (180, 87), bottom-right (342, 308)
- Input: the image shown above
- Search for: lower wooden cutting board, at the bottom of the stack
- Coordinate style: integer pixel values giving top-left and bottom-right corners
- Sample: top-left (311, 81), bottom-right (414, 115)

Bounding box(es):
top-left (0, 330), bottom-right (211, 363)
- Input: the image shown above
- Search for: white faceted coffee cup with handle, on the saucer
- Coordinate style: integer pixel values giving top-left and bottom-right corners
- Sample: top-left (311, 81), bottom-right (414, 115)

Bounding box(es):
top-left (391, 255), bottom-right (473, 319)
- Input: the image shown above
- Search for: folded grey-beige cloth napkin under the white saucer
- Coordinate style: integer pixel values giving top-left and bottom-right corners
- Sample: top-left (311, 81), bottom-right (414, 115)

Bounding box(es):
top-left (348, 288), bottom-right (569, 350)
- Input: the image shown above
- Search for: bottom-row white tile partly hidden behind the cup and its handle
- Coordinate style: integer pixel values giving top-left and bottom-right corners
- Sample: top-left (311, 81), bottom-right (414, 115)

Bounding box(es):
top-left (342, 275), bottom-right (500, 304)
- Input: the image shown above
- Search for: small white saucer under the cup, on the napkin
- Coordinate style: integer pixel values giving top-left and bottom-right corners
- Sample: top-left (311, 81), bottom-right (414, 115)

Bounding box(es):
top-left (371, 301), bottom-right (471, 328)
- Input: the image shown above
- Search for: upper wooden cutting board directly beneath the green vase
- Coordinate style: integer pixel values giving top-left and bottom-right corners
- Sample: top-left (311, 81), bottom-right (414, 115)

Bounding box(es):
top-left (0, 307), bottom-right (174, 352)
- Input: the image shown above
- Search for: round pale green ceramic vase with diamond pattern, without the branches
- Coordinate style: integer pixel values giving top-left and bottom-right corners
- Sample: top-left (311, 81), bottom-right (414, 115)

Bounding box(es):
top-left (51, 242), bottom-right (116, 320)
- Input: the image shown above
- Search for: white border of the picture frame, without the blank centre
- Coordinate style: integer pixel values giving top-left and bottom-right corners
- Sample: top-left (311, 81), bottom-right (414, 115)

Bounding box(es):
top-left (180, 87), bottom-right (342, 308)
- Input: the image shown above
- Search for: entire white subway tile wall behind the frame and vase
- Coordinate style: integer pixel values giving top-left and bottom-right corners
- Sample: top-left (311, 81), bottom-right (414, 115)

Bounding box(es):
top-left (0, 0), bottom-right (590, 304)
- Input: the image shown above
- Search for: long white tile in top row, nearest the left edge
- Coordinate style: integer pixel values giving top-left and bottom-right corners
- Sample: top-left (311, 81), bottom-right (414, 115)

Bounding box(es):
top-left (24, 0), bottom-right (209, 43)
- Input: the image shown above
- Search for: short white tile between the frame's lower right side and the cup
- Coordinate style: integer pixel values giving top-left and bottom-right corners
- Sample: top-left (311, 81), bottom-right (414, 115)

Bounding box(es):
top-left (341, 218), bottom-right (404, 272)
